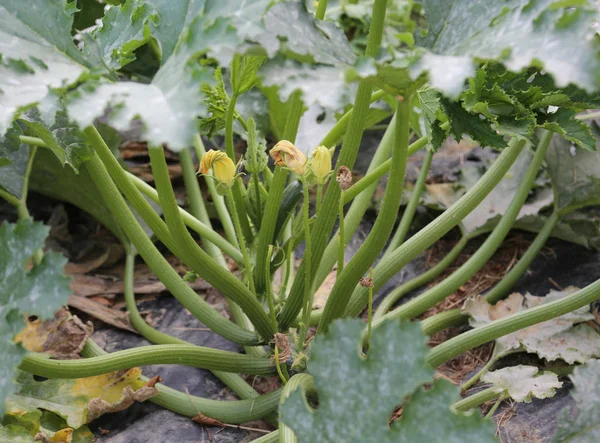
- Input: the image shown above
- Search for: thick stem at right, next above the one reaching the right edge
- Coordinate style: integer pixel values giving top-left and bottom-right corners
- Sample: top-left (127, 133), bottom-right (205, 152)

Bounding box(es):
top-left (421, 211), bottom-right (560, 334)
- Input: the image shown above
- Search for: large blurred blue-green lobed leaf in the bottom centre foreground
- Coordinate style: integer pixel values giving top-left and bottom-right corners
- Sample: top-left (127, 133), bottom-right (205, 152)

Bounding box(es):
top-left (280, 320), bottom-right (496, 443)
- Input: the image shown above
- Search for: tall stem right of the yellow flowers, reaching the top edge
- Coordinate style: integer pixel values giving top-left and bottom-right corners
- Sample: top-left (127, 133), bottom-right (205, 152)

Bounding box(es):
top-left (278, 0), bottom-right (387, 330)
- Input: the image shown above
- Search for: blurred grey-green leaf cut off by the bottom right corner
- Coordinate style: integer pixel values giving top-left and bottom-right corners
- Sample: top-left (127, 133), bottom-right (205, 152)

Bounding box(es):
top-left (552, 360), bottom-right (600, 443)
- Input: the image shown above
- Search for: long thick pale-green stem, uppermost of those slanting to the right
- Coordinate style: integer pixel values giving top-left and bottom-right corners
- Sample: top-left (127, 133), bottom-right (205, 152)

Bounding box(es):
top-left (346, 139), bottom-right (526, 317)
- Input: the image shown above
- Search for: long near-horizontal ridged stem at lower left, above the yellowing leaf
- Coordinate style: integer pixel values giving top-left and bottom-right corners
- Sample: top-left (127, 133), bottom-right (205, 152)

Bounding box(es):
top-left (19, 344), bottom-right (275, 378)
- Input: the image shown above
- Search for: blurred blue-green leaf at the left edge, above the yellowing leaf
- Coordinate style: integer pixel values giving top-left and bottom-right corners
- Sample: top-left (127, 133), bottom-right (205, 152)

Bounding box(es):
top-left (0, 220), bottom-right (71, 415)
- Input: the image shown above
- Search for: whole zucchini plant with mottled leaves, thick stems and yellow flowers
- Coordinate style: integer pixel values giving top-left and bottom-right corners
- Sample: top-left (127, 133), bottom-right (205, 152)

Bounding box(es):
top-left (0, 0), bottom-right (600, 442)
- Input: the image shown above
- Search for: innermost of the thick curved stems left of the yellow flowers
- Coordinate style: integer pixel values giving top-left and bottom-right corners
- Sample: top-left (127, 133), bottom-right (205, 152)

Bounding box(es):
top-left (148, 148), bottom-right (275, 340)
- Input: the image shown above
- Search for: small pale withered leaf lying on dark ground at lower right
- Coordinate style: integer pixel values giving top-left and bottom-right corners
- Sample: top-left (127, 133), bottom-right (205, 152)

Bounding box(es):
top-left (481, 365), bottom-right (562, 403)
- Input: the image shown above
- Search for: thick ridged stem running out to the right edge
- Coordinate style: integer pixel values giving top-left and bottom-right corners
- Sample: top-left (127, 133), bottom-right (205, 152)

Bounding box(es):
top-left (427, 280), bottom-right (600, 367)
